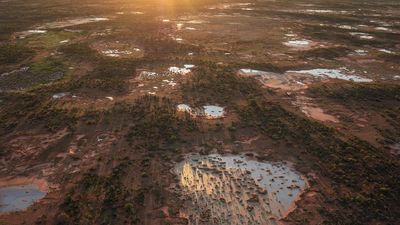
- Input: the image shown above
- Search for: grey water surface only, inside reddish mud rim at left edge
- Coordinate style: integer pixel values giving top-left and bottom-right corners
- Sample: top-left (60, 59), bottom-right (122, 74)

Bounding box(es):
top-left (0, 184), bottom-right (46, 213)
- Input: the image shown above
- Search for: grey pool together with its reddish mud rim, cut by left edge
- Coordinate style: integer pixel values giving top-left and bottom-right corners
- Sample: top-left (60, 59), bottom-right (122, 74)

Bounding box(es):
top-left (0, 178), bottom-right (49, 213)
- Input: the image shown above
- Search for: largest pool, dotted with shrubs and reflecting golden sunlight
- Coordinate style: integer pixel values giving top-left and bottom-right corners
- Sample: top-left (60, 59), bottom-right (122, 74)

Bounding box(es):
top-left (174, 154), bottom-right (307, 225)
